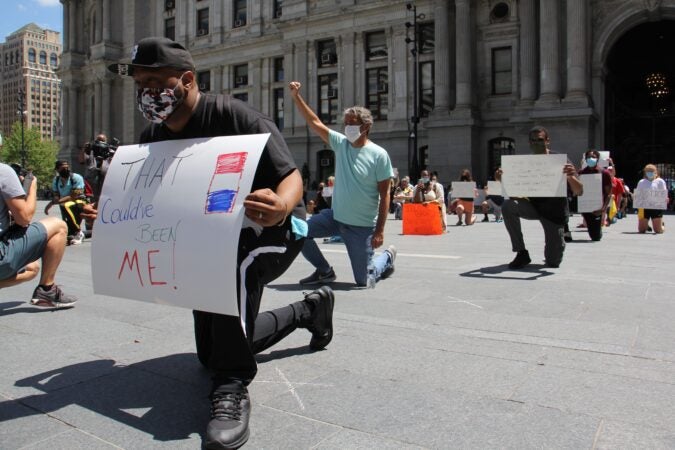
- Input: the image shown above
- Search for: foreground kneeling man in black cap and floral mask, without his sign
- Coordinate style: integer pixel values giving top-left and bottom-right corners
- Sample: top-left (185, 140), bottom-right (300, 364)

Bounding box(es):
top-left (90, 37), bottom-right (334, 448)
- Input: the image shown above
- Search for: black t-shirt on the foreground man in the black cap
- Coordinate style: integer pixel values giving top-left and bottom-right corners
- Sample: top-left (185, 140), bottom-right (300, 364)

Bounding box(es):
top-left (140, 93), bottom-right (306, 219)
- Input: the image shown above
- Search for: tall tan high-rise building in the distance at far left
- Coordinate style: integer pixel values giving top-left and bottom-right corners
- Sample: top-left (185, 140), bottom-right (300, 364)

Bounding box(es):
top-left (0, 23), bottom-right (61, 140)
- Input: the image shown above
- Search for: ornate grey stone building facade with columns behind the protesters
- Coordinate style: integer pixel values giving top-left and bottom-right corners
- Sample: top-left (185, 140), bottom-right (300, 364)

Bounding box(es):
top-left (59, 0), bottom-right (675, 187)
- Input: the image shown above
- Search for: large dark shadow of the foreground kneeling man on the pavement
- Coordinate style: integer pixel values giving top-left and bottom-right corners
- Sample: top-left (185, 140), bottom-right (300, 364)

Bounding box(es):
top-left (0, 353), bottom-right (211, 441)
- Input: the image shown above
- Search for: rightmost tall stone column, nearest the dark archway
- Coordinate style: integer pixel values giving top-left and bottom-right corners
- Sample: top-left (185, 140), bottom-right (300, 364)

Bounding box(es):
top-left (565, 0), bottom-right (588, 102)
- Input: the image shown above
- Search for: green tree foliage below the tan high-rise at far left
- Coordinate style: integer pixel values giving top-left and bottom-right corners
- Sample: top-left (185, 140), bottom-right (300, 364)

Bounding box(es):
top-left (0, 122), bottom-right (59, 187)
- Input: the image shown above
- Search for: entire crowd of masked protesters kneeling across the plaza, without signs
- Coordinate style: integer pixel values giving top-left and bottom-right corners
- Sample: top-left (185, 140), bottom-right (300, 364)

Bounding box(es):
top-left (0, 37), bottom-right (666, 448)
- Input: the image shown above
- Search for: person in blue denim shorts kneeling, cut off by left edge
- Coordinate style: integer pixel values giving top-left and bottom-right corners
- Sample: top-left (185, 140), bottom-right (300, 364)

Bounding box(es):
top-left (0, 151), bottom-right (77, 308)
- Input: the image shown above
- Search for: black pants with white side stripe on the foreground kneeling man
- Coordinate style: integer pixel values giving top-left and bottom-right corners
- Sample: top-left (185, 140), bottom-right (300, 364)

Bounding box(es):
top-left (193, 220), bottom-right (304, 386)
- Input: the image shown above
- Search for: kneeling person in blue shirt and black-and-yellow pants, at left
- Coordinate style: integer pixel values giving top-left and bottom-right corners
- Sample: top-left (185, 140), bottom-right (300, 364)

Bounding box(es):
top-left (45, 160), bottom-right (87, 245)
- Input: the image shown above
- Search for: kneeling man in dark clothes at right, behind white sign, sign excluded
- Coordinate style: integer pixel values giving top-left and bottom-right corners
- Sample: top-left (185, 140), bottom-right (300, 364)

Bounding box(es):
top-left (502, 126), bottom-right (583, 269)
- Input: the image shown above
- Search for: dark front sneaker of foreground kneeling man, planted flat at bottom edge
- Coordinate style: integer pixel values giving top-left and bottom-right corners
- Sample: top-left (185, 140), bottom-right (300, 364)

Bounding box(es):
top-left (204, 383), bottom-right (251, 449)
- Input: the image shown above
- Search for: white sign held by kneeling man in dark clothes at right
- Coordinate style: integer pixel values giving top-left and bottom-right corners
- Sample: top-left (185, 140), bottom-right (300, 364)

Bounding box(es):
top-left (502, 154), bottom-right (567, 197)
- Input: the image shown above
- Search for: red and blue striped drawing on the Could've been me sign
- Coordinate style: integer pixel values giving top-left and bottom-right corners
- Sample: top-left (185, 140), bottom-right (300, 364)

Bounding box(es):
top-left (204, 152), bottom-right (248, 214)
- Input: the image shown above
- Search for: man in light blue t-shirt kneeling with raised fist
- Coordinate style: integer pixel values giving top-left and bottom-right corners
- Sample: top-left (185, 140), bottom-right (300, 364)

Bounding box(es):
top-left (289, 81), bottom-right (396, 287)
